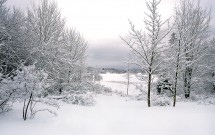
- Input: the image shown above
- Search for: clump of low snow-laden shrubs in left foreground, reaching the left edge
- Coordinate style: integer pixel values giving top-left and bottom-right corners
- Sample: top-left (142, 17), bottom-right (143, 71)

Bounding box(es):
top-left (0, 65), bottom-right (58, 120)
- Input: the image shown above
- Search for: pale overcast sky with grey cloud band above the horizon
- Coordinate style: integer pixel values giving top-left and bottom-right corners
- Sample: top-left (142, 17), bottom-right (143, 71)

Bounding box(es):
top-left (5, 0), bottom-right (215, 68)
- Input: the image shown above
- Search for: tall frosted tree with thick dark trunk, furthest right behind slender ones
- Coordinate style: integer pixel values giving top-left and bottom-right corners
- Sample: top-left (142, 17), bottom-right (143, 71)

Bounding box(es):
top-left (175, 0), bottom-right (211, 98)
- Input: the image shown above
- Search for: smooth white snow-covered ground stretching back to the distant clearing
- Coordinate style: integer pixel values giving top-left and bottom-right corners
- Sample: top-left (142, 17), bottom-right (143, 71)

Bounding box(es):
top-left (0, 74), bottom-right (215, 135)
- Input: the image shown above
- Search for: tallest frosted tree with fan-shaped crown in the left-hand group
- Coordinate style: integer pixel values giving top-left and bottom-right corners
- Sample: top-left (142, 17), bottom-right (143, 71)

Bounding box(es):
top-left (27, 0), bottom-right (65, 79)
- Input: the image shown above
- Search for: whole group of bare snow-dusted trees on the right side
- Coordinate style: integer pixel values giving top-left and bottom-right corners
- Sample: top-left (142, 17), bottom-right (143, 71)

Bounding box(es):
top-left (122, 0), bottom-right (215, 107)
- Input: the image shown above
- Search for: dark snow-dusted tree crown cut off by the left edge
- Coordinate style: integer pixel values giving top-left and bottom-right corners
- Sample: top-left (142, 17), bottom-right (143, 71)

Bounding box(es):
top-left (0, 0), bottom-right (29, 75)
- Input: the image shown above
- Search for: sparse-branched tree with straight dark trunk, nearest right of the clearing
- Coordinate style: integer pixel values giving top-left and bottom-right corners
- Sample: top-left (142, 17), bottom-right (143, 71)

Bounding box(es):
top-left (122, 0), bottom-right (170, 107)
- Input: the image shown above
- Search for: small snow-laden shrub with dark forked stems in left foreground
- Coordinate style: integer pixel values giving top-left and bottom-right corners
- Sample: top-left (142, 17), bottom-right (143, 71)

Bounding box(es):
top-left (14, 65), bottom-right (58, 120)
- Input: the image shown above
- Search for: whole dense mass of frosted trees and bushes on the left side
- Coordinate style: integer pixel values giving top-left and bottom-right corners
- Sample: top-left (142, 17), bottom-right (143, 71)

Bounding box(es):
top-left (0, 0), bottom-right (98, 120)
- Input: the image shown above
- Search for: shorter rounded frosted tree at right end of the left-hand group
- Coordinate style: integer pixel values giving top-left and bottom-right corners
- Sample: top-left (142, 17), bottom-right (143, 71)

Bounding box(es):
top-left (55, 29), bottom-right (87, 92)
